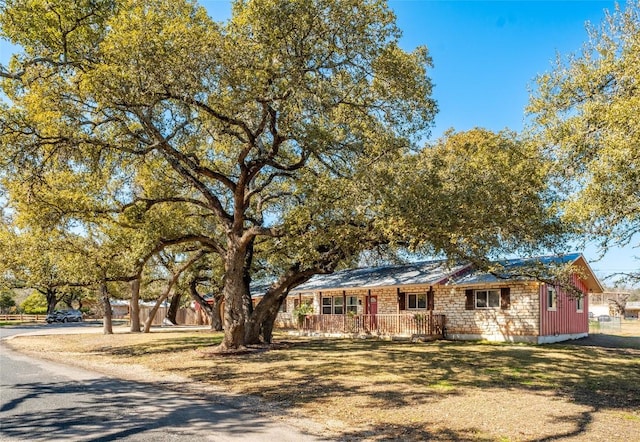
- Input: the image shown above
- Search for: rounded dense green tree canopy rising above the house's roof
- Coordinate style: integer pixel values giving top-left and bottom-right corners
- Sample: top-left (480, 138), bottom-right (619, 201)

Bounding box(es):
top-left (387, 128), bottom-right (569, 267)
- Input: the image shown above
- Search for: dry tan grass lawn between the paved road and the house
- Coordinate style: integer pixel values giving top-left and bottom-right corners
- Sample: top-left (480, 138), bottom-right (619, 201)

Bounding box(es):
top-left (13, 332), bottom-right (640, 441)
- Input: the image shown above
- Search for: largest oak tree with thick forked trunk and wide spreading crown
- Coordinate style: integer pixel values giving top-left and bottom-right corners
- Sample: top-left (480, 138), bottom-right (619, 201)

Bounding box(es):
top-left (0, 0), bottom-right (435, 348)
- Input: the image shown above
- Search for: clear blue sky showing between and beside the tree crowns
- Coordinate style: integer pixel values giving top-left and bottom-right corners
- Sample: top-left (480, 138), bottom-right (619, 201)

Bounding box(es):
top-left (0, 0), bottom-right (640, 286)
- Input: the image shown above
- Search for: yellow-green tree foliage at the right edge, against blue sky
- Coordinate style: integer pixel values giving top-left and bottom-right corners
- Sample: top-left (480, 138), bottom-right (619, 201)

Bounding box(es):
top-left (528, 0), bottom-right (640, 281)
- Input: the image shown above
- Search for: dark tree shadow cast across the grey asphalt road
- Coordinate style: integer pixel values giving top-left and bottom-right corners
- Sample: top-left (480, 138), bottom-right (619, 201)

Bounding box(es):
top-left (0, 378), bottom-right (278, 441)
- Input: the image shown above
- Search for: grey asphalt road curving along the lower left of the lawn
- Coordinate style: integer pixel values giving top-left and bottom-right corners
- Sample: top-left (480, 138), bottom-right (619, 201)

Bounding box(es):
top-left (0, 324), bottom-right (320, 442)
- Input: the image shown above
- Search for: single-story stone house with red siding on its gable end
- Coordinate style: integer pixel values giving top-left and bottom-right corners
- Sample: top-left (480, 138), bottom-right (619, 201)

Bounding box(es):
top-left (279, 253), bottom-right (603, 343)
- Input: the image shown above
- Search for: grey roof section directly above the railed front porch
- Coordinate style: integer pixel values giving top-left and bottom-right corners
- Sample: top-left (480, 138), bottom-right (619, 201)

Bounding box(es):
top-left (293, 260), bottom-right (469, 292)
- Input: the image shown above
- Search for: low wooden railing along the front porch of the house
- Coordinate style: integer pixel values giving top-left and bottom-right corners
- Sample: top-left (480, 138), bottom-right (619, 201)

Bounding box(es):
top-left (302, 313), bottom-right (445, 336)
